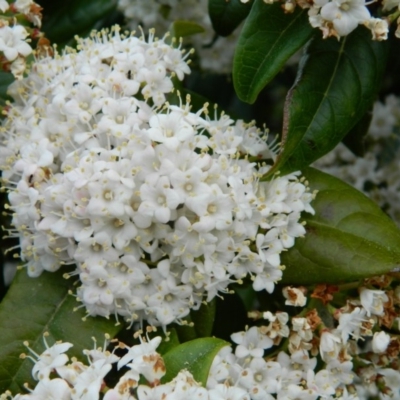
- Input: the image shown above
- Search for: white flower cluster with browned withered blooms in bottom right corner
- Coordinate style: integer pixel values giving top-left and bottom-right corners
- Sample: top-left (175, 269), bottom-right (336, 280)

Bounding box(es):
top-left (207, 287), bottom-right (400, 400)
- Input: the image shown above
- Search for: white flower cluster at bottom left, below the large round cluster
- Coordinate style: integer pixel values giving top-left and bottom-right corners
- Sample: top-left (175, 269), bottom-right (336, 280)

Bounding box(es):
top-left (0, 337), bottom-right (209, 400)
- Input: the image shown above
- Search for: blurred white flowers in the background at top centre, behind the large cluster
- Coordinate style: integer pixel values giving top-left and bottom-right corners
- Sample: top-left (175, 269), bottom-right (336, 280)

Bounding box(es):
top-left (118, 0), bottom-right (239, 73)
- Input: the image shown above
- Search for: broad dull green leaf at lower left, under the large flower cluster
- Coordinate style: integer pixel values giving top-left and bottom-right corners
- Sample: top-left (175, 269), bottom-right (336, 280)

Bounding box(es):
top-left (0, 269), bottom-right (121, 393)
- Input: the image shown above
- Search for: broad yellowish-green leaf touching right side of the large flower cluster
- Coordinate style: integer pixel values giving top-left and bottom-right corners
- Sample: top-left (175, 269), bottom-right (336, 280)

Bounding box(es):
top-left (282, 168), bottom-right (400, 285)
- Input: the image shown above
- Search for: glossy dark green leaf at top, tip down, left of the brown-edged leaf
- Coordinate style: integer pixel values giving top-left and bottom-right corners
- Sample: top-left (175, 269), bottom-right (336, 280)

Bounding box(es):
top-left (233, 0), bottom-right (314, 103)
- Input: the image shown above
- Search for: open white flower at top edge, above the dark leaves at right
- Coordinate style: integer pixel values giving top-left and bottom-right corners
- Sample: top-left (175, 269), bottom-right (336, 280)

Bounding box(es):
top-left (320, 0), bottom-right (370, 36)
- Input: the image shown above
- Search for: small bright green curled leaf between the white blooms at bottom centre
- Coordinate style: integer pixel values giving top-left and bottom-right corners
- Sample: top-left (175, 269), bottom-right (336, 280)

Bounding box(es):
top-left (162, 338), bottom-right (229, 387)
